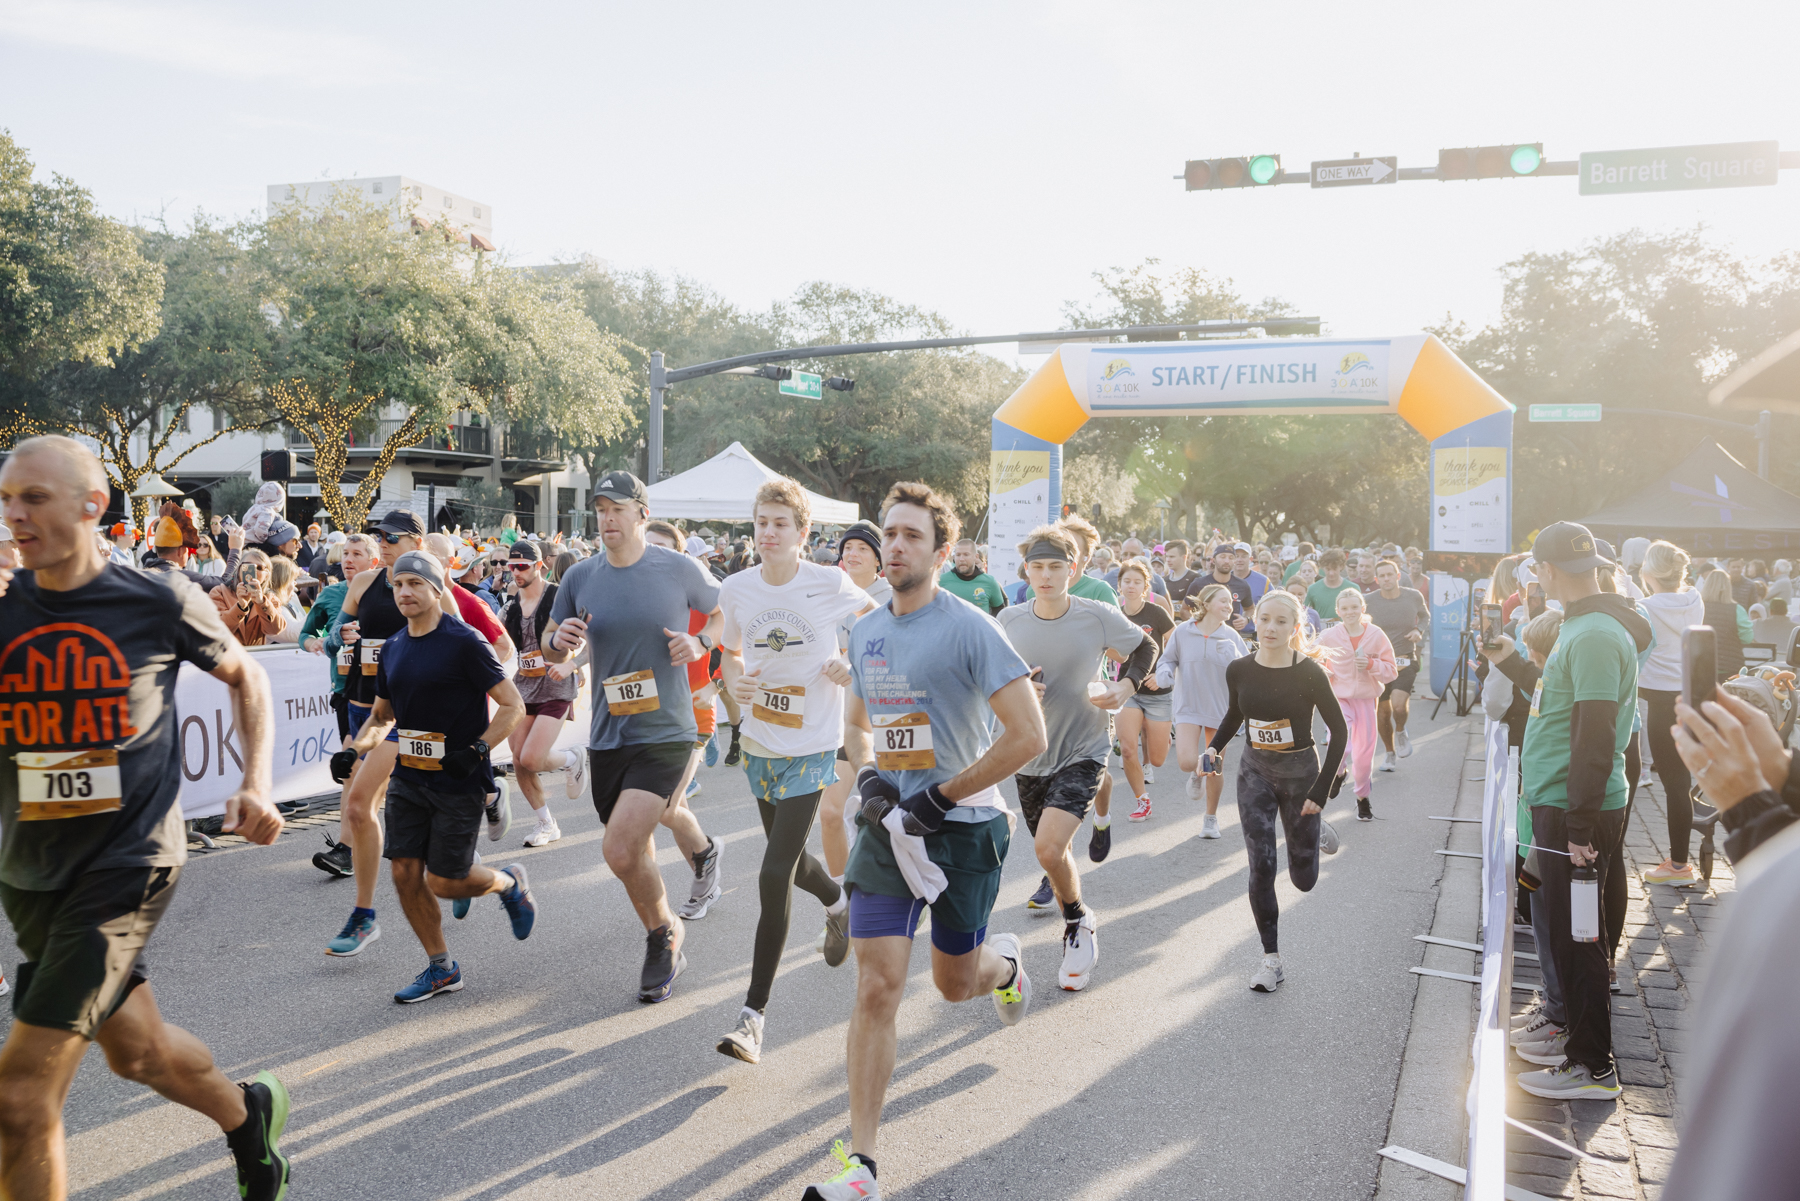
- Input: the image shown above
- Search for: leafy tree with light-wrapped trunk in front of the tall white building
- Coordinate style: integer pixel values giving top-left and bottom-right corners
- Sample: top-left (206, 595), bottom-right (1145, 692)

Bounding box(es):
top-left (254, 189), bottom-right (630, 529)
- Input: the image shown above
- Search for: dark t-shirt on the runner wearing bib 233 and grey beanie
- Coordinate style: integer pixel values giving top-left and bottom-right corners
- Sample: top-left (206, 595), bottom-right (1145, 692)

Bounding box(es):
top-left (374, 614), bottom-right (506, 796)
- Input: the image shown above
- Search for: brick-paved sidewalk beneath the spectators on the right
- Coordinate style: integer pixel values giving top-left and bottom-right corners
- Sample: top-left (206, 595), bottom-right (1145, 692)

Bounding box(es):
top-left (1507, 767), bottom-right (1735, 1201)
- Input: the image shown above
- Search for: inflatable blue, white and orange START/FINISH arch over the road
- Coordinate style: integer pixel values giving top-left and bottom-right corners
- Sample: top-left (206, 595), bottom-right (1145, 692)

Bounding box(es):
top-left (988, 333), bottom-right (1512, 690)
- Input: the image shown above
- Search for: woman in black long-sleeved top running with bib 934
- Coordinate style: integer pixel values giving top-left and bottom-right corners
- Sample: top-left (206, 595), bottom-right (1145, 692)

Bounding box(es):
top-left (1201, 586), bottom-right (1354, 992)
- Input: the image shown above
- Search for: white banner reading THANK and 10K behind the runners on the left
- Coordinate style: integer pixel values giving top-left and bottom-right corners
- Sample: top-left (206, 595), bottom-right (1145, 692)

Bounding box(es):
top-left (175, 646), bottom-right (589, 819)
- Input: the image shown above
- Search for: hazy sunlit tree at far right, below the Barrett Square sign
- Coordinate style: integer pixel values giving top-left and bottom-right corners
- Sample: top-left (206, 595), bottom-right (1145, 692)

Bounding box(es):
top-left (1435, 229), bottom-right (1800, 537)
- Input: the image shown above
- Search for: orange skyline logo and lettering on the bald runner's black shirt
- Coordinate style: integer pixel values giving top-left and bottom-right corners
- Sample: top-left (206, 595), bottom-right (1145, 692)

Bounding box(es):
top-left (0, 621), bottom-right (139, 747)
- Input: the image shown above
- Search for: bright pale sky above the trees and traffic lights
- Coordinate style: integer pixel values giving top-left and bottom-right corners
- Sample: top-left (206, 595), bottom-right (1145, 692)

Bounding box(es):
top-left (0, 0), bottom-right (1800, 363)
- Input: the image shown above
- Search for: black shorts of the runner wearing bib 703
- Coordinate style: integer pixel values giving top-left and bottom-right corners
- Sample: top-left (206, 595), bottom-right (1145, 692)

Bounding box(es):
top-left (0, 868), bottom-right (182, 1039)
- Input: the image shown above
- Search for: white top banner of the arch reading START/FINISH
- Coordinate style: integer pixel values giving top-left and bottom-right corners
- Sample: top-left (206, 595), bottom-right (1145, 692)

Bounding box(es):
top-left (1064, 339), bottom-right (1417, 416)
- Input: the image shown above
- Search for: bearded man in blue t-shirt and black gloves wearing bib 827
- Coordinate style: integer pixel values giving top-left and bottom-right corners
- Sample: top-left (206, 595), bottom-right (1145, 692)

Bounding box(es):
top-left (803, 483), bottom-right (1048, 1201)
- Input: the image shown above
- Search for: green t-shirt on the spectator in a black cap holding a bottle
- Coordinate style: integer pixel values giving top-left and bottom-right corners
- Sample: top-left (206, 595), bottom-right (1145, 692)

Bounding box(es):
top-left (1521, 612), bottom-right (1638, 808)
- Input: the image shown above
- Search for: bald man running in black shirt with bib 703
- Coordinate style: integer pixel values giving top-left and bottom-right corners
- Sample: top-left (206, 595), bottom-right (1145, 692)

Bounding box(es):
top-left (0, 436), bottom-right (288, 1201)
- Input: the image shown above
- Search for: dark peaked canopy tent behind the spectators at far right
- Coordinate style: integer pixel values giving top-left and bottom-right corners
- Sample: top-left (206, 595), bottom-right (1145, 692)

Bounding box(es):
top-left (1582, 438), bottom-right (1800, 556)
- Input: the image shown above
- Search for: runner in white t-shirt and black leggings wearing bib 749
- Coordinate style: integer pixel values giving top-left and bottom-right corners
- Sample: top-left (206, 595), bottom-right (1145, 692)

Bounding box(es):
top-left (718, 477), bottom-right (875, 1064)
